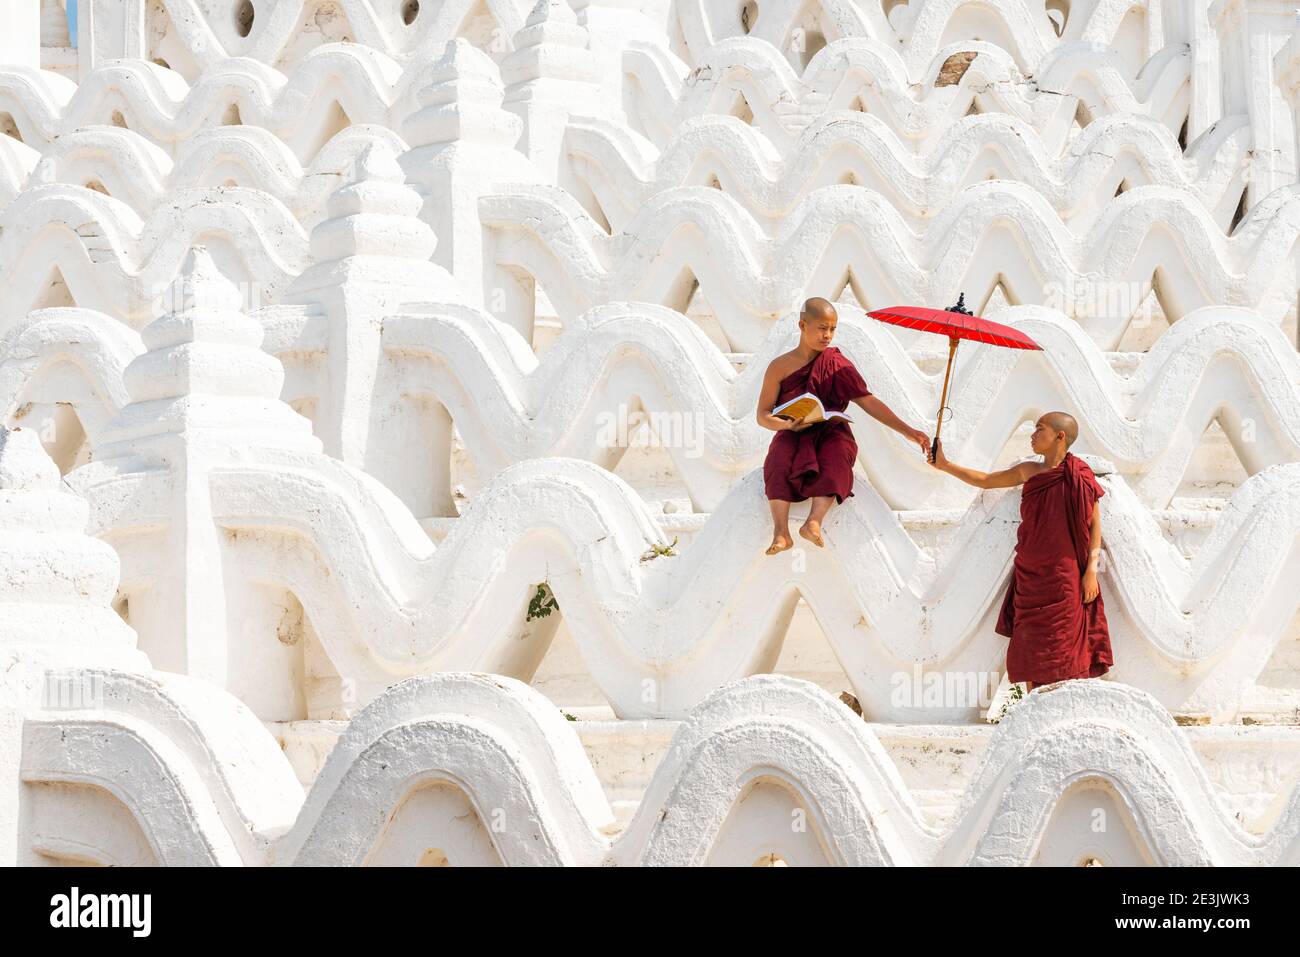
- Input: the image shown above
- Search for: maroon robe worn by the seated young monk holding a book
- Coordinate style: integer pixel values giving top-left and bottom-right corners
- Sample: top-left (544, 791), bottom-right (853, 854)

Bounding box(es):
top-left (763, 346), bottom-right (871, 502)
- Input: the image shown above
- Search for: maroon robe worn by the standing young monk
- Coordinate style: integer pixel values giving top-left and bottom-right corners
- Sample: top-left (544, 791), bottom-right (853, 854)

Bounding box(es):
top-left (996, 452), bottom-right (1114, 685)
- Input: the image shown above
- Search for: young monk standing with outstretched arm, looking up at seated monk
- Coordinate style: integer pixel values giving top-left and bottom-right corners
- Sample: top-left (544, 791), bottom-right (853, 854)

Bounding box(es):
top-left (933, 412), bottom-right (1114, 690)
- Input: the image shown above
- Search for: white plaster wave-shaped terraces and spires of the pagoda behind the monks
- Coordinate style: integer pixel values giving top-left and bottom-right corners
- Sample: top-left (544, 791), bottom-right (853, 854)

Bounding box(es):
top-left (0, 0), bottom-right (1300, 866)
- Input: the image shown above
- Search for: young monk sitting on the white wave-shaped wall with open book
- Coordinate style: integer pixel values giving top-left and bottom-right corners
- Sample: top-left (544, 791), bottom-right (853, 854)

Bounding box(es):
top-left (757, 296), bottom-right (930, 555)
